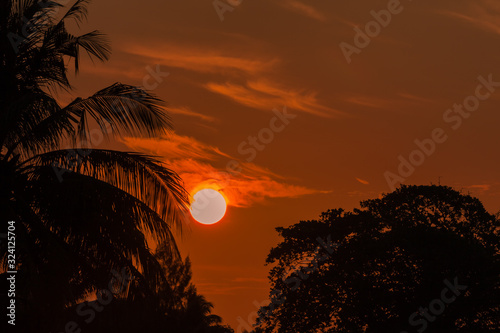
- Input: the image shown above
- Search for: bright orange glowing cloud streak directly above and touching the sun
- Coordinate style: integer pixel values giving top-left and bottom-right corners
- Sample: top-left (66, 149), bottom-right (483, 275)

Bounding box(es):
top-left (122, 133), bottom-right (328, 207)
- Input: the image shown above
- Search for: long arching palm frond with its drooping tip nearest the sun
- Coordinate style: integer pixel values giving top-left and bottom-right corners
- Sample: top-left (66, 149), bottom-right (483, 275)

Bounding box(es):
top-left (23, 149), bottom-right (188, 232)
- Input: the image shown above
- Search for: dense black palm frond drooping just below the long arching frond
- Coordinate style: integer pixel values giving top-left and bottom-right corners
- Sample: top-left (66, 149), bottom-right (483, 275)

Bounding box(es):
top-left (18, 166), bottom-right (180, 290)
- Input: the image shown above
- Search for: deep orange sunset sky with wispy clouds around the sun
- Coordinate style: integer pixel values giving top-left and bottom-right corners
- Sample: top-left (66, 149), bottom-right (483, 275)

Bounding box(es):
top-left (64, 0), bottom-right (500, 329)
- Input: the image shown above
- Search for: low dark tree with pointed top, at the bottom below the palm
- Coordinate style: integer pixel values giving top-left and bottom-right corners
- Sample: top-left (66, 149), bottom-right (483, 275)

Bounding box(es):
top-left (53, 245), bottom-right (233, 333)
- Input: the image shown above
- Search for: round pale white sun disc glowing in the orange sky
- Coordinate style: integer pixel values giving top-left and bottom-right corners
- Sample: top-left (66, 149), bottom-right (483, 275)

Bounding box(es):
top-left (191, 188), bottom-right (227, 224)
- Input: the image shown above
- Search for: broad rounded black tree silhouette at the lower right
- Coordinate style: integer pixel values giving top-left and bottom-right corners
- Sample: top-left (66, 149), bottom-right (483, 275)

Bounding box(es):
top-left (255, 186), bottom-right (500, 333)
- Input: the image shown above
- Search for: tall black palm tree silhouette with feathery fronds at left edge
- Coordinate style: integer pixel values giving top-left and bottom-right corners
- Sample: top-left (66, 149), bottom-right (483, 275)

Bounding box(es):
top-left (0, 0), bottom-right (187, 325)
